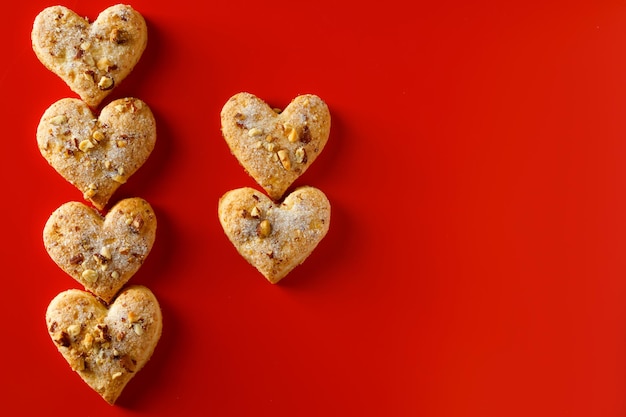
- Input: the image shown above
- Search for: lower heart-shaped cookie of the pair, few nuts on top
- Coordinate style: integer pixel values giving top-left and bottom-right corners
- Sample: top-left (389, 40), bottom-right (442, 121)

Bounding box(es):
top-left (218, 186), bottom-right (330, 284)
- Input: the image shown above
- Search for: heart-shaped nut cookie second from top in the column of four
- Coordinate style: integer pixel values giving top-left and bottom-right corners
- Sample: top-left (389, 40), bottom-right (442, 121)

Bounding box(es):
top-left (37, 98), bottom-right (156, 210)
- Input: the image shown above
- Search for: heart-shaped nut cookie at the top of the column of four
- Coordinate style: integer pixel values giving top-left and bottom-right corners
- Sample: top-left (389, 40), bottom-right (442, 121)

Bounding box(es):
top-left (31, 4), bottom-right (148, 107)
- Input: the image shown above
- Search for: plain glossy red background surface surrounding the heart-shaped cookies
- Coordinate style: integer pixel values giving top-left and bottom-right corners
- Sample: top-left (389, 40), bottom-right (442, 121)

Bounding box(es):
top-left (0, 0), bottom-right (626, 417)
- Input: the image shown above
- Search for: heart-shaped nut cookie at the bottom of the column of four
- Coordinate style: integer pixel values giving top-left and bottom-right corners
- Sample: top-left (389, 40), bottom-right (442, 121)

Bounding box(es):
top-left (46, 286), bottom-right (163, 404)
